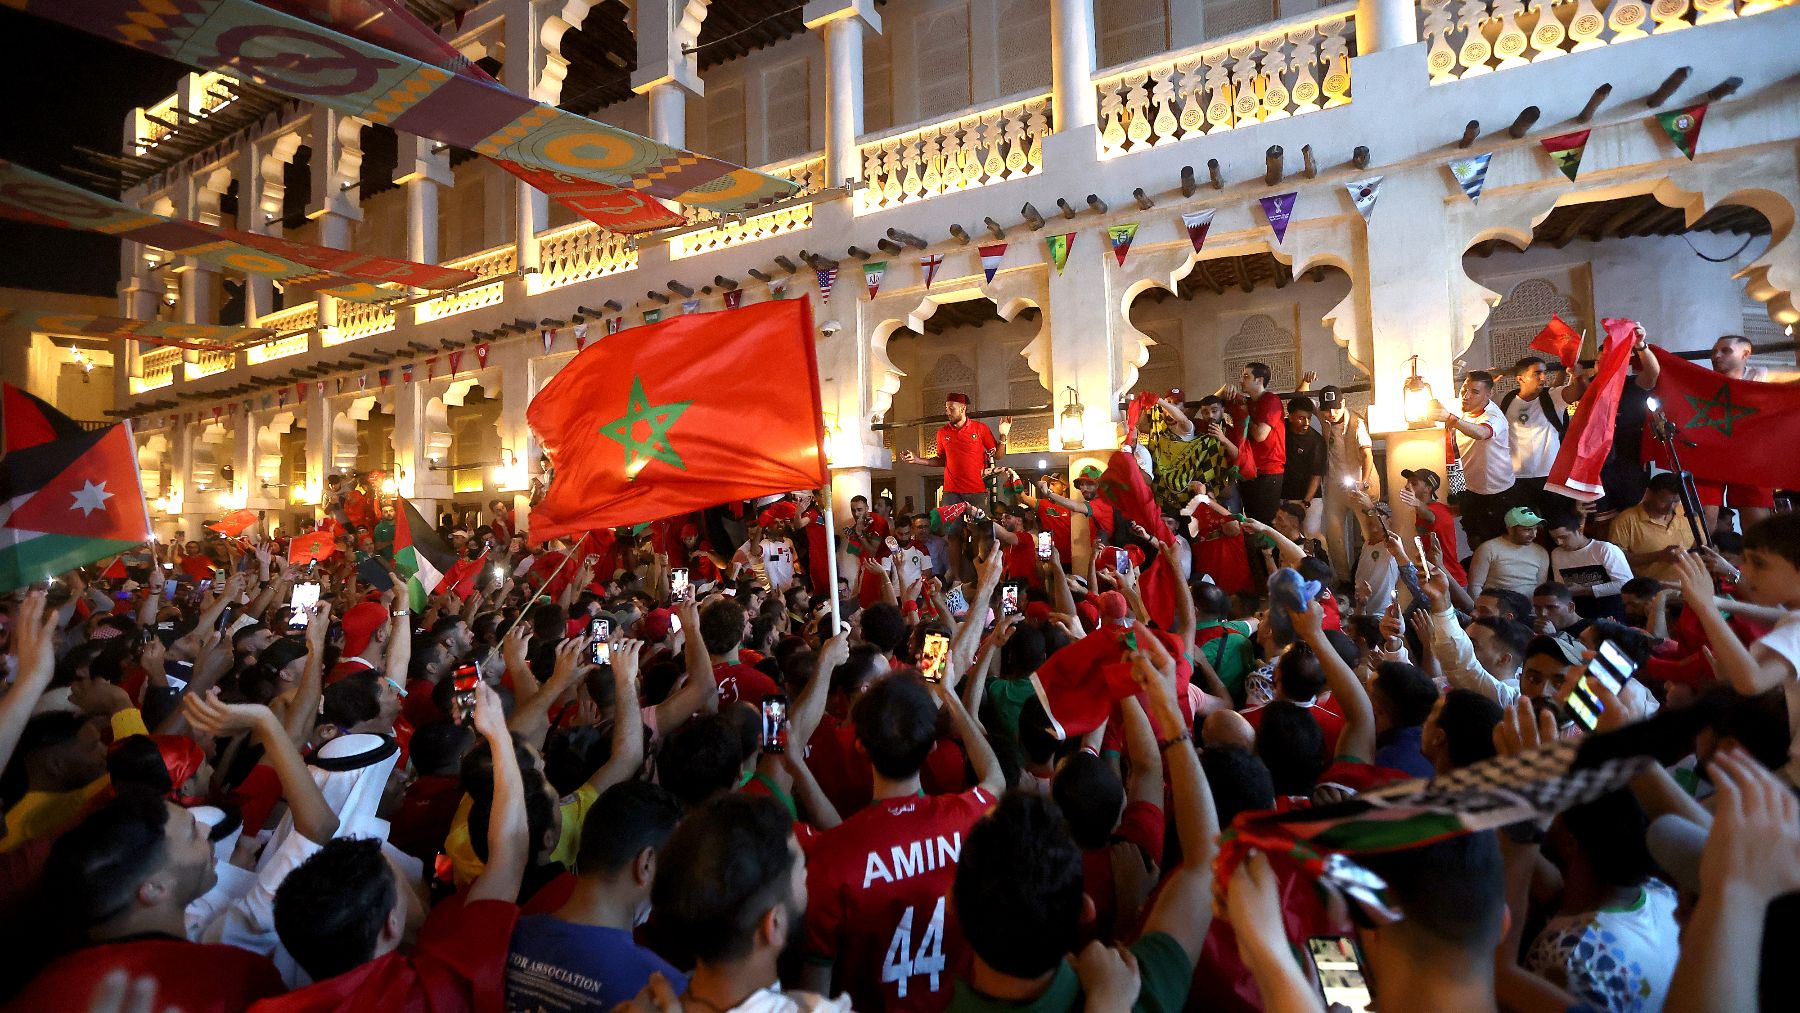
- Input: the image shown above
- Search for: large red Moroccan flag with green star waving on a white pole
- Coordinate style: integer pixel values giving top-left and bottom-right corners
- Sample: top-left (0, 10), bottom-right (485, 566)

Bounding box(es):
top-left (526, 299), bottom-right (826, 542)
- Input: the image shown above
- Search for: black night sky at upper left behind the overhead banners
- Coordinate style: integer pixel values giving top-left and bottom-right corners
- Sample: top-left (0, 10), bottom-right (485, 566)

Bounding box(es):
top-left (0, 9), bottom-right (187, 295)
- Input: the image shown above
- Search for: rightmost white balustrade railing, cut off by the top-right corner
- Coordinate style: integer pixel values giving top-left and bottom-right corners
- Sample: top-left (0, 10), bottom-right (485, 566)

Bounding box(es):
top-left (1418, 0), bottom-right (1795, 85)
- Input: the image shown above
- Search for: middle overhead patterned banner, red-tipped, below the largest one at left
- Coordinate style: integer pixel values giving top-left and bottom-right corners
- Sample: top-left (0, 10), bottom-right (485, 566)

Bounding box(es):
top-left (0, 162), bottom-right (477, 302)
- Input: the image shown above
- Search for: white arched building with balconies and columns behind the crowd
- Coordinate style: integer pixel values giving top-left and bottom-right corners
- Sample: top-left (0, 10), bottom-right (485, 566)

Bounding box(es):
top-left (77, 0), bottom-right (1800, 534)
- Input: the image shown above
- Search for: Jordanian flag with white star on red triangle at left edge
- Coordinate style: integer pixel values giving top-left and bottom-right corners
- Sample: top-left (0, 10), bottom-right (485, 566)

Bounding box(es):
top-left (0, 424), bottom-right (149, 594)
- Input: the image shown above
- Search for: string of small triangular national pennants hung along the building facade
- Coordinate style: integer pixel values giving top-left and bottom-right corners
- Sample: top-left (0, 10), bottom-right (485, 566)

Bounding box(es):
top-left (135, 103), bottom-right (1706, 426)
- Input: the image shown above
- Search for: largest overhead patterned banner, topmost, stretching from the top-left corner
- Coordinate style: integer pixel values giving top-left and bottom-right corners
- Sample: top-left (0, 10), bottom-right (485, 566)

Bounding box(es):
top-left (11, 0), bottom-right (797, 230)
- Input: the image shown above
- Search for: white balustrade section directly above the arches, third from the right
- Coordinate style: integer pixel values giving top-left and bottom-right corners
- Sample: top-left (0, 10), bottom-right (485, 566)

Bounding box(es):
top-left (857, 94), bottom-right (1051, 214)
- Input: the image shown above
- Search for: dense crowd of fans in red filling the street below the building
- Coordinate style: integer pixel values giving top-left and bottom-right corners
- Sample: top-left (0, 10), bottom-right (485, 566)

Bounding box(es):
top-left (0, 338), bottom-right (1800, 1013)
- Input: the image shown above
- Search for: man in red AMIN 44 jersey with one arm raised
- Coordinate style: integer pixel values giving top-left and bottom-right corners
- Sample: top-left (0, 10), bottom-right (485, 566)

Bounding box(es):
top-left (801, 671), bottom-right (1006, 1013)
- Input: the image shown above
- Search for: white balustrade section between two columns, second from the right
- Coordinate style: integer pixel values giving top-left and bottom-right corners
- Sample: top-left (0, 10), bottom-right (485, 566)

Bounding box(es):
top-left (1094, 4), bottom-right (1355, 158)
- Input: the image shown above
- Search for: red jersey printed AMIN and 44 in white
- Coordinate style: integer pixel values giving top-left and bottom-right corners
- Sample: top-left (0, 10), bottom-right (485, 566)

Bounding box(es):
top-left (806, 788), bottom-right (994, 1013)
